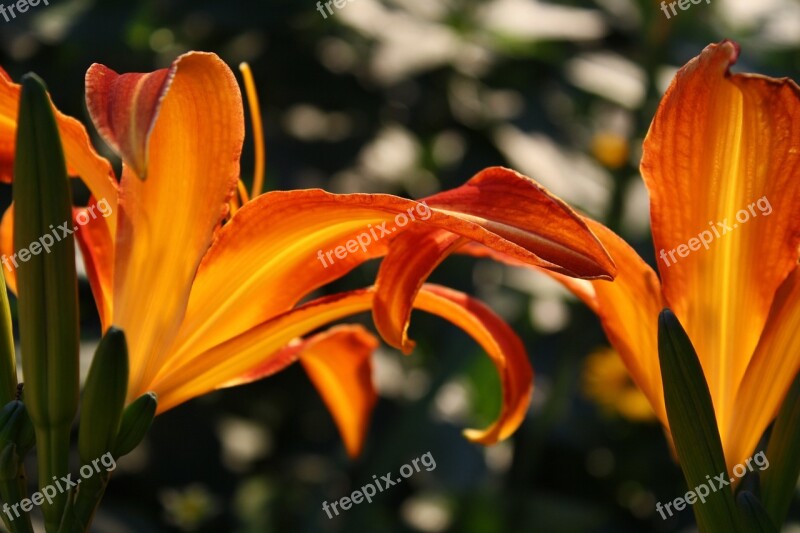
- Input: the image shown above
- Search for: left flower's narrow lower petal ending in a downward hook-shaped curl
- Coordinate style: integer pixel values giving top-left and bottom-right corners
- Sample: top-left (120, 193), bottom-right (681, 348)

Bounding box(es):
top-left (154, 285), bottom-right (533, 444)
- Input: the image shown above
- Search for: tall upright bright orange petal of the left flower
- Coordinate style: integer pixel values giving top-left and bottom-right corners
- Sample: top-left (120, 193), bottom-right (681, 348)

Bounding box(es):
top-left (95, 52), bottom-right (244, 392)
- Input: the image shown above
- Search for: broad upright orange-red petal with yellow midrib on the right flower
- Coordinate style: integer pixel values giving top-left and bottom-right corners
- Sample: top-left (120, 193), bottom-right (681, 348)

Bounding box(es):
top-left (642, 41), bottom-right (800, 435)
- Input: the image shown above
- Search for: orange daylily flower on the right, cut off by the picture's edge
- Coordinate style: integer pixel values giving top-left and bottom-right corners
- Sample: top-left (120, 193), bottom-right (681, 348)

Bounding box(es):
top-left (468, 41), bottom-right (800, 467)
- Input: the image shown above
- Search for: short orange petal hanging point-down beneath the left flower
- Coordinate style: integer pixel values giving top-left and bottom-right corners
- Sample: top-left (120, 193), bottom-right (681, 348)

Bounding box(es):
top-left (218, 325), bottom-right (378, 457)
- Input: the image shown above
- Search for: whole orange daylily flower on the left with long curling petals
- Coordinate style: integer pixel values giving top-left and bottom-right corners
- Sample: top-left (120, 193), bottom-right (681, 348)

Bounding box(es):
top-left (0, 52), bottom-right (615, 454)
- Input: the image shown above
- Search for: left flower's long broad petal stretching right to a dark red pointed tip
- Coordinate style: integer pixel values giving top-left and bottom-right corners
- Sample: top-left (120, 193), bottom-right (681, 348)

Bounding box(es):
top-left (170, 168), bottom-right (614, 370)
